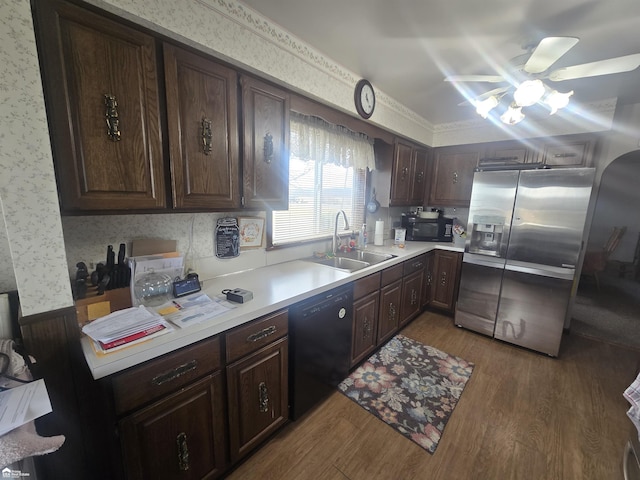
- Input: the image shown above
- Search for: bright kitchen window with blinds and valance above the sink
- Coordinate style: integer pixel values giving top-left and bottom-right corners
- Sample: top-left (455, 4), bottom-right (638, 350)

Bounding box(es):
top-left (271, 112), bottom-right (375, 246)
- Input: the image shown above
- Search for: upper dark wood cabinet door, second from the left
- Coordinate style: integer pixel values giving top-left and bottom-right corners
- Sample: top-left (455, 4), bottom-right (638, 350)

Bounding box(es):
top-left (164, 44), bottom-right (240, 209)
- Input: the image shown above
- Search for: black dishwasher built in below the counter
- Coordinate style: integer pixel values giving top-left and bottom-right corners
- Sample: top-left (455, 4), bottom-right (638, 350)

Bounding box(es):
top-left (289, 284), bottom-right (353, 420)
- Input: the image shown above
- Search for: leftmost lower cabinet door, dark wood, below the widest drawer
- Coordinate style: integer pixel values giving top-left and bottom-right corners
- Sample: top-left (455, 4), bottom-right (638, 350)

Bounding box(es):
top-left (120, 372), bottom-right (226, 480)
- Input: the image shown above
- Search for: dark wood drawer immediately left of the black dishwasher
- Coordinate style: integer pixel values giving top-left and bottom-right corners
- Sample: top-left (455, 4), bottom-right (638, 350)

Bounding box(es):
top-left (226, 310), bottom-right (289, 363)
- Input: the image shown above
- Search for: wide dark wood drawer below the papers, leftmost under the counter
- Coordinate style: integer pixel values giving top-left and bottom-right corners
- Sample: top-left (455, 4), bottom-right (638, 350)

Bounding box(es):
top-left (112, 337), bottom-right (221, 414)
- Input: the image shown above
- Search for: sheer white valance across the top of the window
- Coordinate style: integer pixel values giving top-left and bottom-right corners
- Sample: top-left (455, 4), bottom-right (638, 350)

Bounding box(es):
top-left (290, 112), bottom-right (375, 171)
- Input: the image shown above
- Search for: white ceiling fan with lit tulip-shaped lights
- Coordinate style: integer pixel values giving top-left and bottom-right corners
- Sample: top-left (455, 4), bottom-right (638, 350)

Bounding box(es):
top-left (445, 37), bottom-right (640, 125)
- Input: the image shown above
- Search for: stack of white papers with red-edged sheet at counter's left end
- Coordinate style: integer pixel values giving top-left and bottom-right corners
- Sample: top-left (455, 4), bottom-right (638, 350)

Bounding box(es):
top-left (82, 306), bottom-right (173, 353)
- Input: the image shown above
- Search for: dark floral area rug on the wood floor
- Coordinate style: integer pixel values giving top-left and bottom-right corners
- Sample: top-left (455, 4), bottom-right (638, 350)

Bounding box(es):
top-left (338, 335), bottom-right (474, 453)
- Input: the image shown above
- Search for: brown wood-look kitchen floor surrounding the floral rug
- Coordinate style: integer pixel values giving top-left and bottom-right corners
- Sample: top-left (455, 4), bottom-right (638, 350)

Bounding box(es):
top-left (228, 312), bottom-right (640, 480)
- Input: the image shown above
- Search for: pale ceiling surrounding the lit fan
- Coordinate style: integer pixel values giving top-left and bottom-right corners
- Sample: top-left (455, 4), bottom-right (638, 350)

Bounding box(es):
top-left (243, 0), bottom-right (640, 125)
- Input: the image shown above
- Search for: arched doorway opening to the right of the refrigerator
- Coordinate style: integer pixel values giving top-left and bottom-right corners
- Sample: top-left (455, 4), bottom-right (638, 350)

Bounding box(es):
top-left (571, 151), bottom-right (640, 349)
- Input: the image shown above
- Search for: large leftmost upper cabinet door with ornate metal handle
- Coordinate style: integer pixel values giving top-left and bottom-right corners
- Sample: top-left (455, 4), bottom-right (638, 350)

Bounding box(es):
top-left (34, 0), bottom-right (166, 211)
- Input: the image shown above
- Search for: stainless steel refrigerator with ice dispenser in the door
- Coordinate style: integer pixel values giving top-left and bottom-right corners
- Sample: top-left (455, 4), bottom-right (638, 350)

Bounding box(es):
top-left (455, 168), bottom-right (595, 356)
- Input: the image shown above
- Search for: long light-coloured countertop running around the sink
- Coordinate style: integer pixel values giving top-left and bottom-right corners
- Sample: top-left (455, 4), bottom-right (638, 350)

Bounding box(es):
top-left (81, 242), bottom-right (463, 379)
